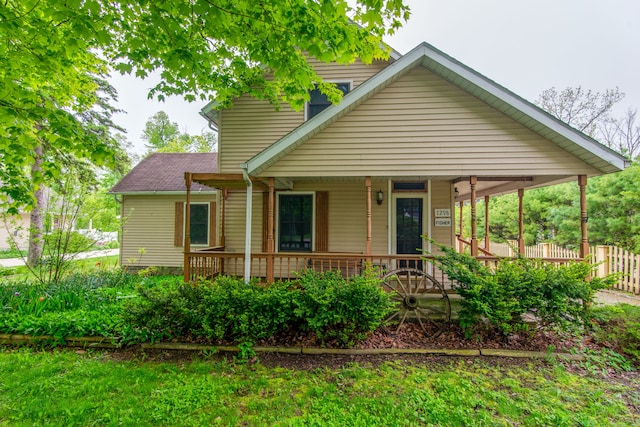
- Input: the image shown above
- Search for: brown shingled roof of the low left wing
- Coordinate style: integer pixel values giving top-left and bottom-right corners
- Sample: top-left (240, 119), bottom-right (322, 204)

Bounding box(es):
top-left (110, 153), bottom-right (218, 194)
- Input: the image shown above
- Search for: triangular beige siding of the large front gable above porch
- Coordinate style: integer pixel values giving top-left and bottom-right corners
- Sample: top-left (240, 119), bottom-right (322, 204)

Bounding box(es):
top-left (261, 67), bottom-right (597, 177)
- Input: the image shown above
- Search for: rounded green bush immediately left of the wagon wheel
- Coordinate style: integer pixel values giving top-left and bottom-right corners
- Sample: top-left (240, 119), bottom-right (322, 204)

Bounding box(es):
top-left (295, 268), bottom-right (393, 346)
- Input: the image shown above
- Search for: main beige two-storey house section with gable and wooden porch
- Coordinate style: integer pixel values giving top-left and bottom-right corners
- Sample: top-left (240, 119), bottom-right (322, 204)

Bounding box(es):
top-left (184, 43), bottom-right (627, 281)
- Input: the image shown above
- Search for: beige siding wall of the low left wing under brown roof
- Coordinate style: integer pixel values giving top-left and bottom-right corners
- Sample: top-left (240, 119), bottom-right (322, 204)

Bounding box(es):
top-left (120, 194), bottom-right (216, 267)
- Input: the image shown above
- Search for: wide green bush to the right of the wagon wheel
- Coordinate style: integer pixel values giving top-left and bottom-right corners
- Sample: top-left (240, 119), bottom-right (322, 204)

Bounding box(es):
top-left (428, 246), bottom-right (614, 335)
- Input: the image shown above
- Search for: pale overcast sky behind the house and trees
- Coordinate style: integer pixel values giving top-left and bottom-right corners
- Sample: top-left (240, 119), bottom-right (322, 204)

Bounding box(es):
top-left (107, 0), bottom-right (640, 152)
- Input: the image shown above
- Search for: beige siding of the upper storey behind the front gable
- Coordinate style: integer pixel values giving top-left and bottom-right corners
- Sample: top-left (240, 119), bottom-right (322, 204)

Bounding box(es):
top-left (218, 60), bottom-right (388, 173)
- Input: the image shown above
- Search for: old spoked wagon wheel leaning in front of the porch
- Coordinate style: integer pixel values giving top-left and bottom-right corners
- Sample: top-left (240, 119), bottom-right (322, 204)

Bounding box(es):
top-left (382, 268), bottom-right (451, 337)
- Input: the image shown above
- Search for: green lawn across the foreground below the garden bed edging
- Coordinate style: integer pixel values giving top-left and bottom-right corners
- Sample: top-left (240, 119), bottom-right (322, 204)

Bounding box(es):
top-left (0, 349), bottom-right (640, 426)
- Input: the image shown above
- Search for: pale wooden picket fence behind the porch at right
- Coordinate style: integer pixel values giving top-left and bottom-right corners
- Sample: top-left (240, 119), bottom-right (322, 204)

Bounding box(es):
top-left (482, 241), bottom-right (640, 294)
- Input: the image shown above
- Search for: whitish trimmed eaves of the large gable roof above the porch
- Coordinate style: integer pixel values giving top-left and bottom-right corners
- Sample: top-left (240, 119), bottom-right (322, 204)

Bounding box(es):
top-left (242, 43), bottom-right (629, 175)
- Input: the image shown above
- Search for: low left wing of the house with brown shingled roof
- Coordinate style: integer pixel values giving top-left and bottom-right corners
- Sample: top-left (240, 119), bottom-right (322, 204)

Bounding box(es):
top-left (110, 153), bottom-right (217, 270)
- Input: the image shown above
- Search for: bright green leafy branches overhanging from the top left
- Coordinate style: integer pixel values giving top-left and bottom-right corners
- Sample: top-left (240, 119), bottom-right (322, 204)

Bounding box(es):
top-left (0, 0), bottom-right (409, 207)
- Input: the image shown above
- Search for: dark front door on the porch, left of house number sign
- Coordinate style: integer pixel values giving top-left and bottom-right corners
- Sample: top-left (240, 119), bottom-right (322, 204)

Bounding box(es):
top-left (395, 197), bottom-right (425, 269)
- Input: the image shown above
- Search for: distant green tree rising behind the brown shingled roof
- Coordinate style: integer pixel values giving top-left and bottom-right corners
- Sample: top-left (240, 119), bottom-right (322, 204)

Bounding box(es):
top-left (142, 111), bottom-right (217, 155)
